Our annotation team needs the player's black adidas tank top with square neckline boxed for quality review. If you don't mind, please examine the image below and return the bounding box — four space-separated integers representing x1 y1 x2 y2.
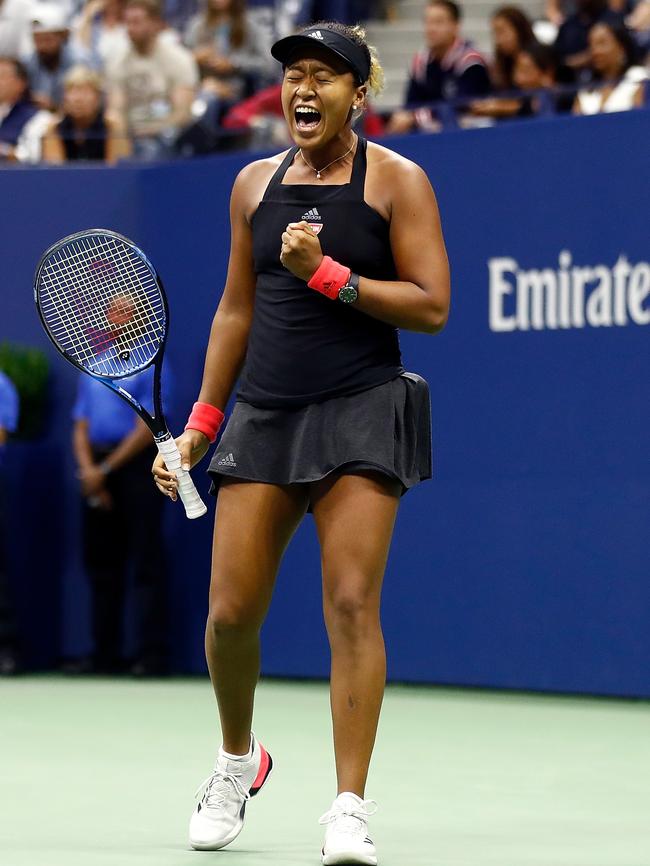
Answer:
237 138 404 408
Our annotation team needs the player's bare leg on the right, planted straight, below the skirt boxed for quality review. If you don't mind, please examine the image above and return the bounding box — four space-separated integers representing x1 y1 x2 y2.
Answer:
312 473 399 797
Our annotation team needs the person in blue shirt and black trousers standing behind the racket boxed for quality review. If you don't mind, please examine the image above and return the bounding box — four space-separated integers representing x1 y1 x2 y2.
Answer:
73 368 167 675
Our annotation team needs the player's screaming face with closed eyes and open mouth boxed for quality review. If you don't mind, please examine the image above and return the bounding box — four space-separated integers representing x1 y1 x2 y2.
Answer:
282 46 365 150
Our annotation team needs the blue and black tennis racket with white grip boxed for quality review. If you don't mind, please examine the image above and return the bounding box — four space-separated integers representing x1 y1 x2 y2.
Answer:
34 229 207 519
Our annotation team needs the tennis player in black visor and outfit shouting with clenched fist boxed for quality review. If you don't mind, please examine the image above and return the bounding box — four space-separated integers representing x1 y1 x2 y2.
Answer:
153 23 449 864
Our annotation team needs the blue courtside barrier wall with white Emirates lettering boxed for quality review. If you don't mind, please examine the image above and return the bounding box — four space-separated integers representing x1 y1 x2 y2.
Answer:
0 112 650 697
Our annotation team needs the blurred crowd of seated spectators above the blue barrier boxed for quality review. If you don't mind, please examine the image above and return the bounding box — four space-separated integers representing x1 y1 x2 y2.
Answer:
0 0 650 163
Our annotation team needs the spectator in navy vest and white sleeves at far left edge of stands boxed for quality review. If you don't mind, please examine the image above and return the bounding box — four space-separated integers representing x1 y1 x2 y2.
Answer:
0 57 52 162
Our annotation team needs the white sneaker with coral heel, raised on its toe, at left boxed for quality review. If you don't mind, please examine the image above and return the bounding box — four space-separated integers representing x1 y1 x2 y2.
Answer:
190 734 273 851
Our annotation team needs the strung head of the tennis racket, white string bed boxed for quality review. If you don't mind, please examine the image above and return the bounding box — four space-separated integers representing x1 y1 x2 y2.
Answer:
38 234 166 377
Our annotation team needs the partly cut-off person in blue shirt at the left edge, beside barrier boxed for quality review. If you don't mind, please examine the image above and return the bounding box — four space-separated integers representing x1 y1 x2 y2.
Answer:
0 370 20 676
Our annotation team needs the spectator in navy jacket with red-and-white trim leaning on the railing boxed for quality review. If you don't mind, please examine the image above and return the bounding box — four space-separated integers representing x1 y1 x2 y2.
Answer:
387 0 490 133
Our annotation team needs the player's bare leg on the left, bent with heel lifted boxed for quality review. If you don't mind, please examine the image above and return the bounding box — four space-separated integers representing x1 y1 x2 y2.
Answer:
205 479 307 755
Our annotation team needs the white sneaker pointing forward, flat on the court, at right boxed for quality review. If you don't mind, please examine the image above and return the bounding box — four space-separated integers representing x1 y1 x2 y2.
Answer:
318 791 377 866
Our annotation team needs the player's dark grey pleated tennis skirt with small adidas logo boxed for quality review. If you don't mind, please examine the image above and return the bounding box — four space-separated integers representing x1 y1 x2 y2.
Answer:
208 373 432 496
